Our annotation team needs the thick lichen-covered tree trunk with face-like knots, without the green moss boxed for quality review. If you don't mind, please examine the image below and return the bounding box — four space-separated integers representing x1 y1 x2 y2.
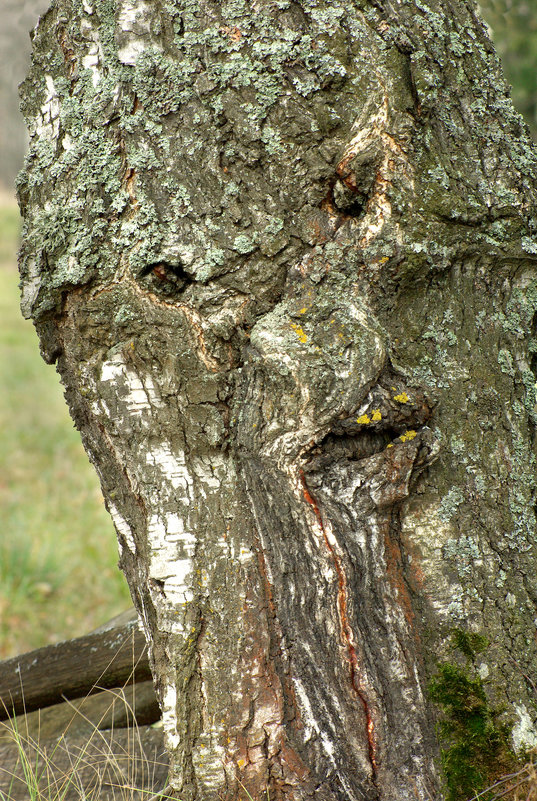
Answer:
19 0 537 801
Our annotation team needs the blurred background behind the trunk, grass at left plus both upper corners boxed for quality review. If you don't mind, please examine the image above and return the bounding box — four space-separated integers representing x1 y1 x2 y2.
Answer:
0 0 537 658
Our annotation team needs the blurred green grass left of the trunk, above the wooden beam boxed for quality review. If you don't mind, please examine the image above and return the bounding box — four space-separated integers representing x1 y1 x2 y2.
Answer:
0 196 130 658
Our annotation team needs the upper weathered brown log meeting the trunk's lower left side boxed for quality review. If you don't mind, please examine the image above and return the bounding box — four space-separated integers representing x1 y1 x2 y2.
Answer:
0 623 151 720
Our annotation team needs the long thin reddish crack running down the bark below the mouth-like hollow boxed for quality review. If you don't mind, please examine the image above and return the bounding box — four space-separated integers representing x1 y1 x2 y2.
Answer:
299 470 377 783
